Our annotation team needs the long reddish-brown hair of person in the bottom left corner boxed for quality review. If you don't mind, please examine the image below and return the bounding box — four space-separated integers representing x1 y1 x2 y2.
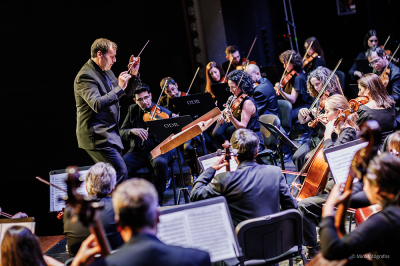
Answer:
1 226 47 266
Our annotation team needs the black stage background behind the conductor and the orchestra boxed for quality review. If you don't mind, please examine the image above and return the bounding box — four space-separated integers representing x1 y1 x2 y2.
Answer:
0 0 400 235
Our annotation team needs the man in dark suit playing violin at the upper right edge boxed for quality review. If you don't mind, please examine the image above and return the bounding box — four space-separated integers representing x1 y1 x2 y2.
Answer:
365 46 400 106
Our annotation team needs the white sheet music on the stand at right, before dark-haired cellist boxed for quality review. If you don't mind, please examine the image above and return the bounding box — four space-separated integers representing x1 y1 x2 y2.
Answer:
326 142 368 184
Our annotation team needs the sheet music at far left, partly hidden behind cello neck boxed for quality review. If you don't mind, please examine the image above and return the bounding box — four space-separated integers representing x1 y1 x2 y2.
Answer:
50 170 88 212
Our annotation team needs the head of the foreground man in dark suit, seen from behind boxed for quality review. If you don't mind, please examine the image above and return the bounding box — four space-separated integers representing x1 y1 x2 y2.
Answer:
113 178 159 232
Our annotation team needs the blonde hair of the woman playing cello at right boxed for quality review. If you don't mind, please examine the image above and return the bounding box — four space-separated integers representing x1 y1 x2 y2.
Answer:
325 94 360 133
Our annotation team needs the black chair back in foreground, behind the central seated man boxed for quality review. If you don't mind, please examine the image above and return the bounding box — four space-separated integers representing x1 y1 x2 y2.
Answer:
236 209 306 266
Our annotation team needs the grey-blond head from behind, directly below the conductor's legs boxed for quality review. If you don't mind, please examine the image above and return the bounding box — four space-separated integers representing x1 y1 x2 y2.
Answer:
86 162 117 198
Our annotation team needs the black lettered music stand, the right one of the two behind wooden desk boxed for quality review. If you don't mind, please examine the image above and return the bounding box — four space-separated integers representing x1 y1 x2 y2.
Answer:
172 93 215 154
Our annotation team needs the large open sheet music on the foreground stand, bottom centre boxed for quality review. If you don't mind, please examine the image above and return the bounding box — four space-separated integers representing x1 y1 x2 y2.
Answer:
157 203 239 262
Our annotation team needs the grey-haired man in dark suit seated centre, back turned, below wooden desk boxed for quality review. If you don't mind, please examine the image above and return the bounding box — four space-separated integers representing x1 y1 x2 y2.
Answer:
190 129 297 226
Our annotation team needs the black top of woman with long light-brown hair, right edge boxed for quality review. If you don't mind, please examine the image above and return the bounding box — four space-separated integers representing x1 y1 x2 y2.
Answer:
357 105 397 145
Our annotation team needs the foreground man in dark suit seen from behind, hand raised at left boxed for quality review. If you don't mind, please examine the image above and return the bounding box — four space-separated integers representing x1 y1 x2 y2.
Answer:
71 178 211 266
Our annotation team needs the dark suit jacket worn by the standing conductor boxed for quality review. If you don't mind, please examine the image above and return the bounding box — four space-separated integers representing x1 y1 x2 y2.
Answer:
74 59 139 150
